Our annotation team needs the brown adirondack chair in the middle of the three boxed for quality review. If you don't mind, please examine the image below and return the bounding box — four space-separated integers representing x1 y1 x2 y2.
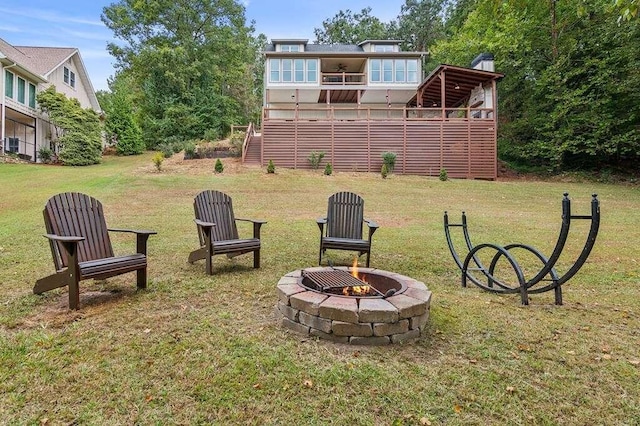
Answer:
189 190 267 275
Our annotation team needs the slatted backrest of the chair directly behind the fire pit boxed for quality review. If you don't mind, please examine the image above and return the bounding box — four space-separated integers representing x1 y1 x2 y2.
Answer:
327 192 364 240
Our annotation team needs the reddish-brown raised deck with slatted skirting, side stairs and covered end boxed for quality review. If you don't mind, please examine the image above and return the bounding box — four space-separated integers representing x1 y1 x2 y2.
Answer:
243 65 502 179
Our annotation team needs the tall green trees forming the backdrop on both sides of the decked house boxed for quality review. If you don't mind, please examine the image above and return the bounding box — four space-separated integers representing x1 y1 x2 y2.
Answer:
100 0 640 173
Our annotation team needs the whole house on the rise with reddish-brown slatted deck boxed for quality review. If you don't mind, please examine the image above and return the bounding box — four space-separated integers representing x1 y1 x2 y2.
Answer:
248 39 502 179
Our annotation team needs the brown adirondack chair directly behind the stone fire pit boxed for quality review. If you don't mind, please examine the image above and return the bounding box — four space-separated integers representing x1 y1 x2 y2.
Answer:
316 192 378 268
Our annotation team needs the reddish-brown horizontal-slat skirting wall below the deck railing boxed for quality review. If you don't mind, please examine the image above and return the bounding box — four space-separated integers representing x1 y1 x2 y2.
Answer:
261 120 497 179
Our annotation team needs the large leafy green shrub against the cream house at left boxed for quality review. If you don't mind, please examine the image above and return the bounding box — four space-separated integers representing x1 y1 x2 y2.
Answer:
37 86 102 166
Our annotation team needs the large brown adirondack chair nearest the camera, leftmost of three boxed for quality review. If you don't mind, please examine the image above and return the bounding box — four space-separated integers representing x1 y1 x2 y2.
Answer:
33 192 156 309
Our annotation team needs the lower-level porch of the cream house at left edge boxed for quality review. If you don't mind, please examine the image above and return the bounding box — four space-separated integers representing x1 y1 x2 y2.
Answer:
0 106 38 162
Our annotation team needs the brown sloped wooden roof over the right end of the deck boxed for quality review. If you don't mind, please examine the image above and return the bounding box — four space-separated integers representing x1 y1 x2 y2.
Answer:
408 64 504 108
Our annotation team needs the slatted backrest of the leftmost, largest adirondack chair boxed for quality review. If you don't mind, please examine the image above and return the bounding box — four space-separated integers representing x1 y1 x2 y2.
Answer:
43 192 113 270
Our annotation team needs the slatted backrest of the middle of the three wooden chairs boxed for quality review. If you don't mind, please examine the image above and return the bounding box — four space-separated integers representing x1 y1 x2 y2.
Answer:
193 190 238 245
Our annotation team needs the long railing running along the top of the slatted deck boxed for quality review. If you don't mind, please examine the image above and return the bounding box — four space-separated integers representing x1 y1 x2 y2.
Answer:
262 106 494 121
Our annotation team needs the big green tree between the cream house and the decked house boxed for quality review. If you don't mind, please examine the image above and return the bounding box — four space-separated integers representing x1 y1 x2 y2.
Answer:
102 0 260 148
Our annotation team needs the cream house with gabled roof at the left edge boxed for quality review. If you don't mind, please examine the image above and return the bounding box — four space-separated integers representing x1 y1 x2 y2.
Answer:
0 39 101 162
